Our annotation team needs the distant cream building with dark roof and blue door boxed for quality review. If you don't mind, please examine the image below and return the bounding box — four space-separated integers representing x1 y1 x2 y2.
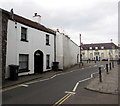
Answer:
81 42 119 60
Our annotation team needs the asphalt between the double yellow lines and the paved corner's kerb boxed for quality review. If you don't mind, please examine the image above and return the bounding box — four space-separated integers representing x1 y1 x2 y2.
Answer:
62 80 118 106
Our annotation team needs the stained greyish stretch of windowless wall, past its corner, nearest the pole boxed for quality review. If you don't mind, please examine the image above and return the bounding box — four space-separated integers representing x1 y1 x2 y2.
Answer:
63 35 80 68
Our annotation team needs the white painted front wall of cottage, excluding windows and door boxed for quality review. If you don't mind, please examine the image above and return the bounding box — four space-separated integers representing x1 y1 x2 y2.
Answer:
6 20 54 78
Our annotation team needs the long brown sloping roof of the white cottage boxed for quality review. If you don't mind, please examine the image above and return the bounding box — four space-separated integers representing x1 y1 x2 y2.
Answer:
2 9 56 35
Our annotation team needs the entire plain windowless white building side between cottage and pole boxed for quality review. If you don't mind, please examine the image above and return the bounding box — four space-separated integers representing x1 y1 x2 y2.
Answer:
56 31 80 70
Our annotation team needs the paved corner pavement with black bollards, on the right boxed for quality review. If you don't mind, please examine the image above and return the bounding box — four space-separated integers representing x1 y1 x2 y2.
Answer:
85 65 120 94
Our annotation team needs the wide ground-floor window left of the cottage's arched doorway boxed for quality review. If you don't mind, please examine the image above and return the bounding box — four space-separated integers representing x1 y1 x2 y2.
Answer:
19 54 29 72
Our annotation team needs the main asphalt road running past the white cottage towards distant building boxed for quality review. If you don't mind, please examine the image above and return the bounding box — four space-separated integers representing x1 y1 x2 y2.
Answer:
2 63 112 104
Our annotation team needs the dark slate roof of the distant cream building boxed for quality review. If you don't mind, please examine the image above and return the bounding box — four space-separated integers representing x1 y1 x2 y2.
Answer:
81 43 119 50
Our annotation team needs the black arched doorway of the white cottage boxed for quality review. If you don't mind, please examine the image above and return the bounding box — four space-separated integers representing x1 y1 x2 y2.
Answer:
34 50 43 73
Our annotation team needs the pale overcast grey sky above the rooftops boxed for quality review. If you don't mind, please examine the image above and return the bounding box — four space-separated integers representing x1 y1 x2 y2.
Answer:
0 0 119 45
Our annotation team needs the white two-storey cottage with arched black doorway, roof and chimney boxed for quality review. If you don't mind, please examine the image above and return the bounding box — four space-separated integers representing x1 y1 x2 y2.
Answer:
4 11 55 78
